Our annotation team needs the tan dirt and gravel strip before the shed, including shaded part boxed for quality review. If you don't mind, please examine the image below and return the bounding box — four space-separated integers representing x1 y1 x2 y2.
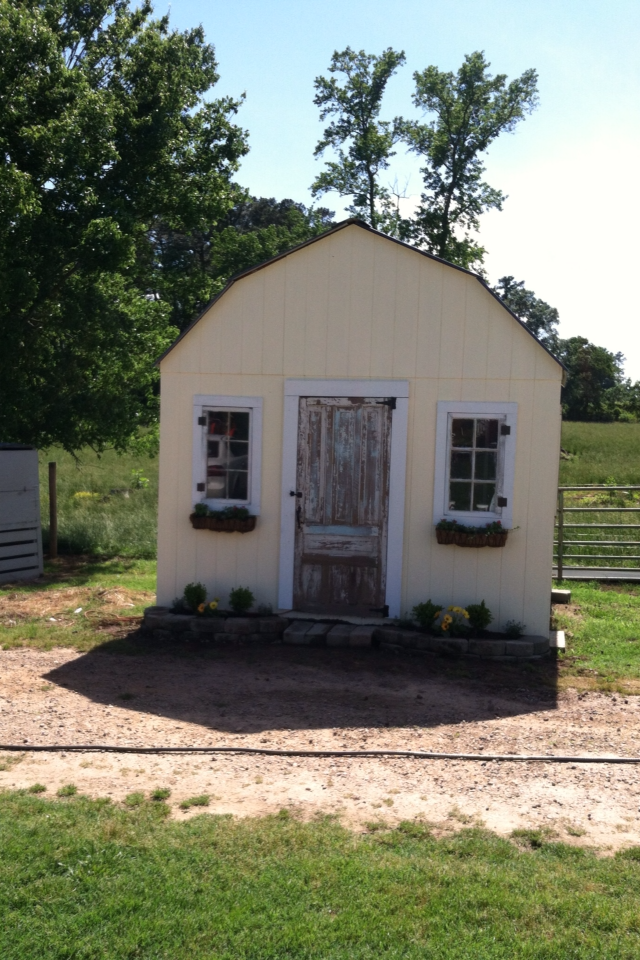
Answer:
0 646 640 850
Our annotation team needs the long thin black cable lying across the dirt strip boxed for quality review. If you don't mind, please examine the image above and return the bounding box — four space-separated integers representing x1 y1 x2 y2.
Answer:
0 743 640 764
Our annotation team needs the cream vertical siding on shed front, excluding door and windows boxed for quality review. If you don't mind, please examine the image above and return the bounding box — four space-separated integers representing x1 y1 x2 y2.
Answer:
158 225 562 634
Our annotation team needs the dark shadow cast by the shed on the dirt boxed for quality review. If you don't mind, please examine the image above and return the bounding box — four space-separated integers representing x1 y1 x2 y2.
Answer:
46 634 557 738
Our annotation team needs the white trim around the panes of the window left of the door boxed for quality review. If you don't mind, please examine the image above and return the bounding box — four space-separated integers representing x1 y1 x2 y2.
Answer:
191 393 262 517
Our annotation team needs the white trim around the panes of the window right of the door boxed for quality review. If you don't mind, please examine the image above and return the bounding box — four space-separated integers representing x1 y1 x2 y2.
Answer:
433 400 518 529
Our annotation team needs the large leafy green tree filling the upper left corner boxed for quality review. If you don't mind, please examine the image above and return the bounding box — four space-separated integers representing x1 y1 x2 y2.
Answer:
0 0 247 450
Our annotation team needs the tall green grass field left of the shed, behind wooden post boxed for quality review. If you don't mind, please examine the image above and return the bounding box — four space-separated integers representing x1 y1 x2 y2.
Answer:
39 449 158 559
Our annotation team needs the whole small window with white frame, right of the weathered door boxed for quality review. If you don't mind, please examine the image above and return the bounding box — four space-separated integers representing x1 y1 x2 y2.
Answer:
434 401 517 525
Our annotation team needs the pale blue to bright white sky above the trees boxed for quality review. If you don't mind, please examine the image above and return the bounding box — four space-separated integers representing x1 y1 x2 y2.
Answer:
166 0 640 380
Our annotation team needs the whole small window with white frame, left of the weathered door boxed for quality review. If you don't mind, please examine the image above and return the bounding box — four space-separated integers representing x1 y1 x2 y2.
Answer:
193 396 262 514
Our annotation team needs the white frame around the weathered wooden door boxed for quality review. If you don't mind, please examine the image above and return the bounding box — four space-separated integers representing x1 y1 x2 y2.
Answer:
278 379 409 617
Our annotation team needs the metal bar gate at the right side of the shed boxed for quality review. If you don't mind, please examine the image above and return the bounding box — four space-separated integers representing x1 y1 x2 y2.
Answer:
553 484 640 580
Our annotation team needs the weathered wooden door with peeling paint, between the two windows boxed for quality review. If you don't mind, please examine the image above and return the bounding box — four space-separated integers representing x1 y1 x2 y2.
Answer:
294 397 393 617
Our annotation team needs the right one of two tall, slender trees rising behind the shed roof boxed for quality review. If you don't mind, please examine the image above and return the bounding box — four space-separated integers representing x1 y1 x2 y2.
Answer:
403 52 538 268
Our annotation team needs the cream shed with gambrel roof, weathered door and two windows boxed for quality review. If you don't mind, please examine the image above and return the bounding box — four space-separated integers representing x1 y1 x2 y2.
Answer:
158 220 563 635
